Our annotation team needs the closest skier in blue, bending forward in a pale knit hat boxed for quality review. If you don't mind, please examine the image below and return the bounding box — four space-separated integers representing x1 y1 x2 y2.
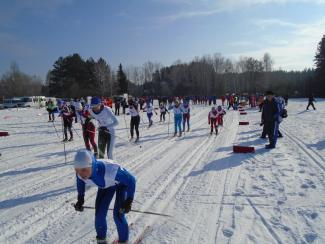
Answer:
74 150 136 243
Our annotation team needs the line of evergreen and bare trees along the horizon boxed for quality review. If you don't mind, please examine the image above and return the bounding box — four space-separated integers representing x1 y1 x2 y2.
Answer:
0 35 325 98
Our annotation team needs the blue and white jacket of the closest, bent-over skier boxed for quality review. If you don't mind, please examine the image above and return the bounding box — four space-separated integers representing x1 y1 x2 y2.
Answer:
76 158 136 199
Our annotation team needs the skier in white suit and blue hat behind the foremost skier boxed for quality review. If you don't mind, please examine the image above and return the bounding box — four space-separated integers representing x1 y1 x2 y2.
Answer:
87 97 118 159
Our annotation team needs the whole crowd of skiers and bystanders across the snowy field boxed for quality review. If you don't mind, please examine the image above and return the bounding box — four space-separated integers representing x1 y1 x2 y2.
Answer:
40 91 315 243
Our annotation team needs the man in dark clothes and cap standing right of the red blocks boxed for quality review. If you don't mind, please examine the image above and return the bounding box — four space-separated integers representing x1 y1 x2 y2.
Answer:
262 91 281 149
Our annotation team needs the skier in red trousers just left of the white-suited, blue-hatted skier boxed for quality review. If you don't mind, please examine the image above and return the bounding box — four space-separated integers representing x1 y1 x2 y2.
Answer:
75 102 98 158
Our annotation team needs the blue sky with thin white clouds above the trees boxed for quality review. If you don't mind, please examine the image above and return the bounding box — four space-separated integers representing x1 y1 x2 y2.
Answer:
0 0 325 78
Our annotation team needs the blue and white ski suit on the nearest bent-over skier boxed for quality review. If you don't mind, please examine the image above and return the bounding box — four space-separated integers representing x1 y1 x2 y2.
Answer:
76 158 136 242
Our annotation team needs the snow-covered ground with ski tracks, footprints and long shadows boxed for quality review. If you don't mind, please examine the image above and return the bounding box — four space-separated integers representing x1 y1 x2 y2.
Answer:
0 100 325 244
